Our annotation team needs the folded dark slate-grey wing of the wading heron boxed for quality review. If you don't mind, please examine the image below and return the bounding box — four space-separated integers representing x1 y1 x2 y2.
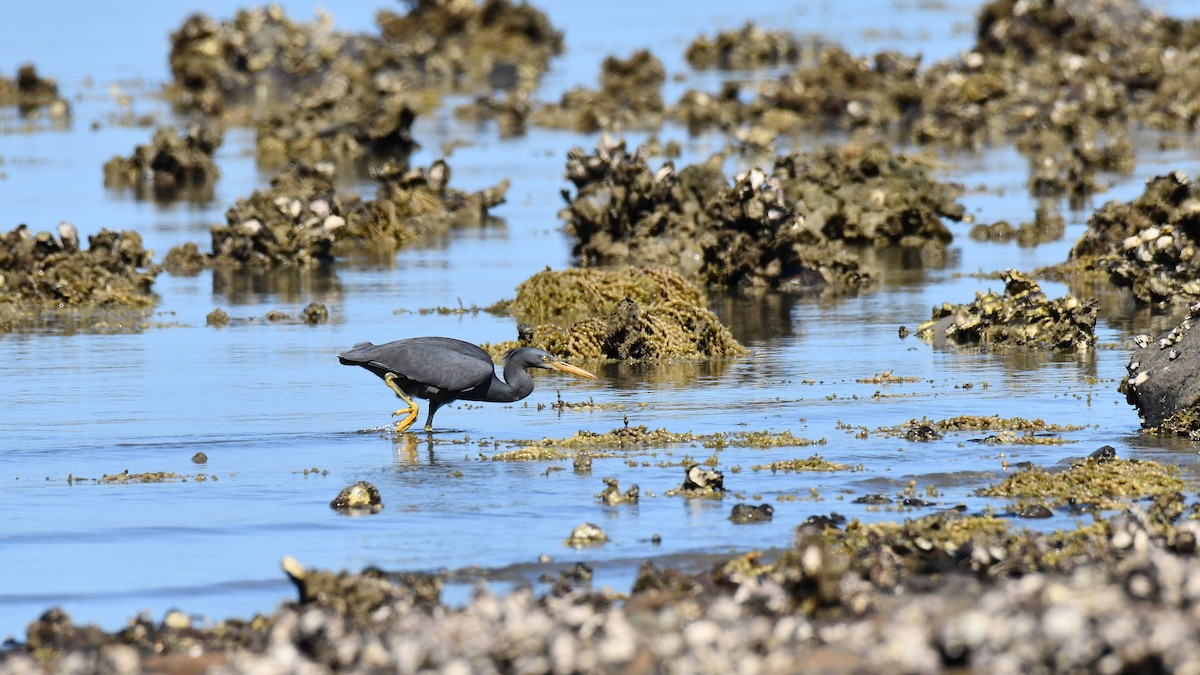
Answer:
347 338 496 392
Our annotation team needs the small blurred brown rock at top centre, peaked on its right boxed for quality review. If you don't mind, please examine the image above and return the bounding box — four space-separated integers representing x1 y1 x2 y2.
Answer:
533 49 666 132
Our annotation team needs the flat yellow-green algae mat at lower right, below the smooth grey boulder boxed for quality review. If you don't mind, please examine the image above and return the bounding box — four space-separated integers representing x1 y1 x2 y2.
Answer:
976 459 1187 508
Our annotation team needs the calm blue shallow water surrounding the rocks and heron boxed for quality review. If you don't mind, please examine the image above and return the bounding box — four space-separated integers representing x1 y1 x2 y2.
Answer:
0 0 1198 638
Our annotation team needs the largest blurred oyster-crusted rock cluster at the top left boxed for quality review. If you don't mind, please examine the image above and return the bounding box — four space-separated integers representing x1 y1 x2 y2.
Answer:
170 0 562 162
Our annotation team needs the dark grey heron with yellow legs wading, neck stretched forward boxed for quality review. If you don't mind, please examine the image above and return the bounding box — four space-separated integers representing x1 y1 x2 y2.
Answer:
337 338 596 432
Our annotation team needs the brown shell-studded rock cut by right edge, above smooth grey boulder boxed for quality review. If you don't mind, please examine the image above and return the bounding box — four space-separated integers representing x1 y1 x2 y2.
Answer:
1062 172 1200 303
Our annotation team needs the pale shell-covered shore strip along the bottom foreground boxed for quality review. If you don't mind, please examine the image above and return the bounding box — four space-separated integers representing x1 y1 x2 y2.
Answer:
16 504 1200 673
